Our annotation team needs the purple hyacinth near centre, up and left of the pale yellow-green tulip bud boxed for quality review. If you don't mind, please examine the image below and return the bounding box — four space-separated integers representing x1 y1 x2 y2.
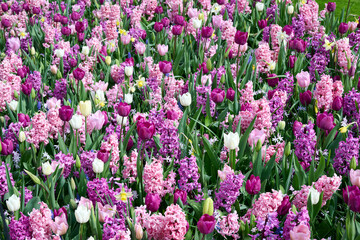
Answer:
178 156 203 201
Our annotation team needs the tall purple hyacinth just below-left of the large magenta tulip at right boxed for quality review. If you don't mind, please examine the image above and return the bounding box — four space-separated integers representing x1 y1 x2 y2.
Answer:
294 122 316 169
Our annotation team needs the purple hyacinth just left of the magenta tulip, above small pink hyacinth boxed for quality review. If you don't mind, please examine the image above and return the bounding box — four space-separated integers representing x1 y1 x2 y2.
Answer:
214 173 245 212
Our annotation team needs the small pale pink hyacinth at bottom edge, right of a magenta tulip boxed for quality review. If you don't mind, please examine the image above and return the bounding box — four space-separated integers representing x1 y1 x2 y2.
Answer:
217 212 240 239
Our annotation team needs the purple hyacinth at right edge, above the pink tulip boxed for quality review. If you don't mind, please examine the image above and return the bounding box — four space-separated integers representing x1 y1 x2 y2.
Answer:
333 134 360 175
